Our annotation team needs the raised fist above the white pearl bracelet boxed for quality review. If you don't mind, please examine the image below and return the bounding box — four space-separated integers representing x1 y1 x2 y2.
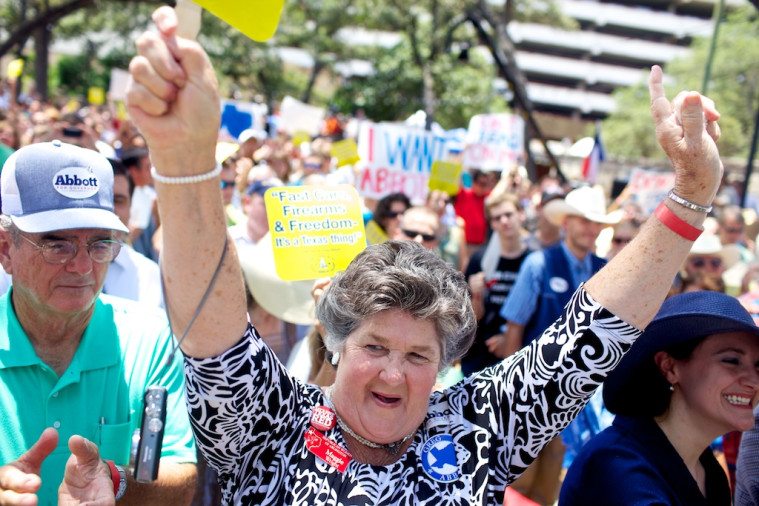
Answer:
127 7 221 171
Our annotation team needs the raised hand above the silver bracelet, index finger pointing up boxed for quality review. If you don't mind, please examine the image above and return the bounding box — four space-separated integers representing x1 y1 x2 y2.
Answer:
648 65 722 205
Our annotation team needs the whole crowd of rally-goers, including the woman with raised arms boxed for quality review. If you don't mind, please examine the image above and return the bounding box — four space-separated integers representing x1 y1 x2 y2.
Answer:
0 4 759 506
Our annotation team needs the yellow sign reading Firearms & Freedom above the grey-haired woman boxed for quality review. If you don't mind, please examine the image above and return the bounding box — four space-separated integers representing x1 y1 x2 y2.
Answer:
264 185 366 281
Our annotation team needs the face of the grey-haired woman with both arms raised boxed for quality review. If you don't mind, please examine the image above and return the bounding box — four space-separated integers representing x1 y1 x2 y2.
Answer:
333 309 441 444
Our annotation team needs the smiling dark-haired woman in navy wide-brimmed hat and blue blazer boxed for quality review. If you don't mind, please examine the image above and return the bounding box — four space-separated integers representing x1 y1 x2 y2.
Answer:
559 291 759 506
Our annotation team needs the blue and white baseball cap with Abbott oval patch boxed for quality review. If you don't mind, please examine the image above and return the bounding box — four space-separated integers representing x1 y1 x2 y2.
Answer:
0 140 128 233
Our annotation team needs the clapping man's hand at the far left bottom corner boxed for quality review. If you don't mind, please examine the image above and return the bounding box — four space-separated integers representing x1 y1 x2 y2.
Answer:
0 428 58 505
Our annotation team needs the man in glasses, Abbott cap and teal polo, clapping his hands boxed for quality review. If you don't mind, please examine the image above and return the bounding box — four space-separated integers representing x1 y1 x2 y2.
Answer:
0 141 196 505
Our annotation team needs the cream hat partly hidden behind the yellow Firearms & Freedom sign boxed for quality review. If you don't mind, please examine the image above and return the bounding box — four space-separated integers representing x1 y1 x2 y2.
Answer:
238 234 315 325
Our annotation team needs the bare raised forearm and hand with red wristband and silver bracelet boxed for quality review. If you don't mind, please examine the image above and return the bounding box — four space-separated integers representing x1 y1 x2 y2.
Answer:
585 66 722 329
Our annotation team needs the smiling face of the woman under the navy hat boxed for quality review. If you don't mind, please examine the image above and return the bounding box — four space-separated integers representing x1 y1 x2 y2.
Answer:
659 332 759 437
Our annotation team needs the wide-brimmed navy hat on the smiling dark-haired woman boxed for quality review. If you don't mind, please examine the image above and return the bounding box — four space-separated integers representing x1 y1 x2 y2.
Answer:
603 291 759 415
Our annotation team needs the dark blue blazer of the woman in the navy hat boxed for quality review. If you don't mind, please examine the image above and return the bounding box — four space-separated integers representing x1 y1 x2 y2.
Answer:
559 415 730 506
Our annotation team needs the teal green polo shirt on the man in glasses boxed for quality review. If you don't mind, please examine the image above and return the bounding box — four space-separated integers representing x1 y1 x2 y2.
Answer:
0 291 195 505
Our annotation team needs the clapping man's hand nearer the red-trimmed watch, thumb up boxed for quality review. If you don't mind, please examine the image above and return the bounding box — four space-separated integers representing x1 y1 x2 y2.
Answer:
58 436 116 506
